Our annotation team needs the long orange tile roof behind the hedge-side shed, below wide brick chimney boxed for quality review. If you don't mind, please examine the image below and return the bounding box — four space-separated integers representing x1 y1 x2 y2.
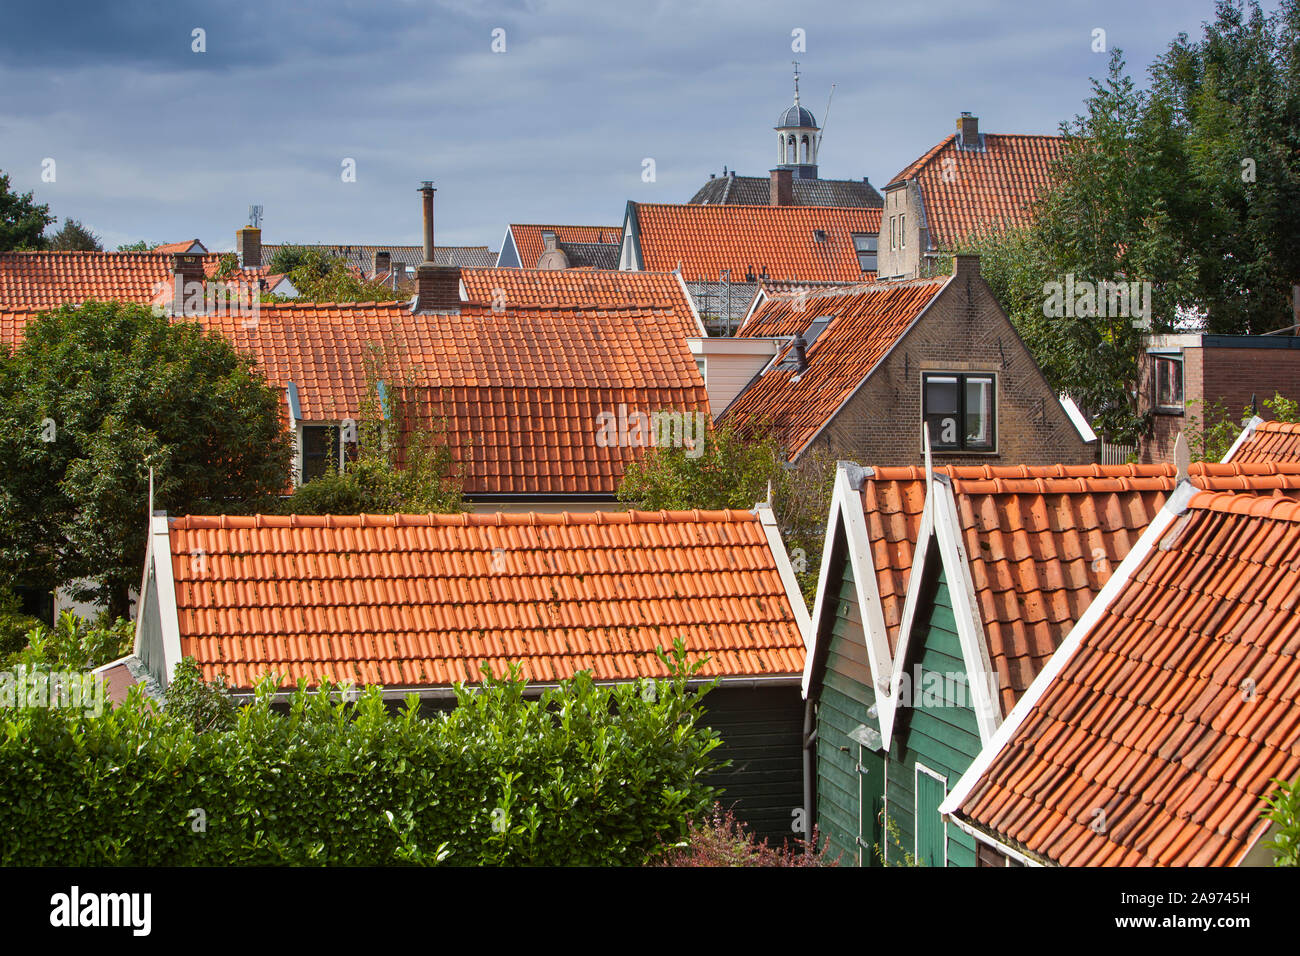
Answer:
189 302 709 496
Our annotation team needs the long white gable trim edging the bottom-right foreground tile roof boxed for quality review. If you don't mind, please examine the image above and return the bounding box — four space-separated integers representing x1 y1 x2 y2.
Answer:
939 481 1197 813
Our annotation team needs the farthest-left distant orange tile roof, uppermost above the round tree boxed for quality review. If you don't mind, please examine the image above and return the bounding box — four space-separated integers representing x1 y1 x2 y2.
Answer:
0 252 221 310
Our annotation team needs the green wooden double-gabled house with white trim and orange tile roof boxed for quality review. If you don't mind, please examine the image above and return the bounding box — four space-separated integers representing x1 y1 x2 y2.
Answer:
803 463 1174 866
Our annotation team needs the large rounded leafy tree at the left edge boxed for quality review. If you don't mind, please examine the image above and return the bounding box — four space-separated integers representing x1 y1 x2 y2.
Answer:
0 302 291 617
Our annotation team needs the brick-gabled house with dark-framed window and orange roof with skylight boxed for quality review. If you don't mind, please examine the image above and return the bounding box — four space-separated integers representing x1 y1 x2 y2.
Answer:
722 256 1096 464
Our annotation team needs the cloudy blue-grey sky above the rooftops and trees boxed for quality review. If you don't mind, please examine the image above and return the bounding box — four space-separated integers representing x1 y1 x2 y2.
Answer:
0 0 1271 251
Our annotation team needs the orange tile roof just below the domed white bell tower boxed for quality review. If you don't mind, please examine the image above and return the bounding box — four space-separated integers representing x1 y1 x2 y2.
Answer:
631 203 880 282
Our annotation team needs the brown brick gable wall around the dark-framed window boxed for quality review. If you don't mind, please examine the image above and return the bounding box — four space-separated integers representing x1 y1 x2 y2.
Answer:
811 265 1097 466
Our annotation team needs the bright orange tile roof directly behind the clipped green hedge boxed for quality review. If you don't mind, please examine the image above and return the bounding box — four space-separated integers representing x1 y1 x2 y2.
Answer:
169 511 803 688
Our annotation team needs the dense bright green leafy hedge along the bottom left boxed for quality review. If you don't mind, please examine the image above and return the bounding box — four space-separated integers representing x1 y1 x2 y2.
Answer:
0 653 719 866
